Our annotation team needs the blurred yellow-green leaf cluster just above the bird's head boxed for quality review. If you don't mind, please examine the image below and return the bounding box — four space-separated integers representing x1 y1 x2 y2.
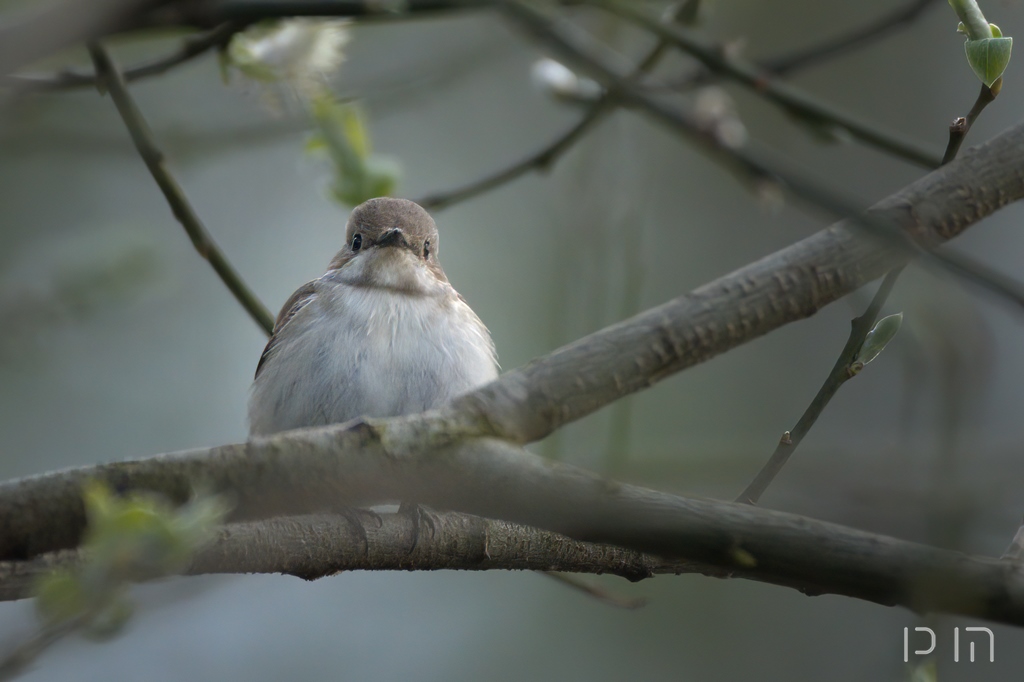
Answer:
306 94 399 206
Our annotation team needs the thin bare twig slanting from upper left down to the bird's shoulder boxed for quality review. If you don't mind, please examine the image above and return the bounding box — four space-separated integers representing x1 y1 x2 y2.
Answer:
89 43 273 335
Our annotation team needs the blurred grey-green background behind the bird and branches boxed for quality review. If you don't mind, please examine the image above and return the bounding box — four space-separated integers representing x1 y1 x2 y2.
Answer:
0 0 1024 682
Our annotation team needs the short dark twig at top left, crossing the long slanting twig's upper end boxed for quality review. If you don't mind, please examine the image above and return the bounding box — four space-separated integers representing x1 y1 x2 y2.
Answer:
4 23 240 91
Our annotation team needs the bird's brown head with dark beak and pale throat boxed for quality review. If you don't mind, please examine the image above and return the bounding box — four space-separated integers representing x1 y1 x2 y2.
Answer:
331 197 447 289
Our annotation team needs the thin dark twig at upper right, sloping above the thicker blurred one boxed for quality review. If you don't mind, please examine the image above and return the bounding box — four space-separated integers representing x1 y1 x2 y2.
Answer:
587 0 941 168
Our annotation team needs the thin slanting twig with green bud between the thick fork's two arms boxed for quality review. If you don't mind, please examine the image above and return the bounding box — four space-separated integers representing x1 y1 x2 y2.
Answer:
736 267 903 505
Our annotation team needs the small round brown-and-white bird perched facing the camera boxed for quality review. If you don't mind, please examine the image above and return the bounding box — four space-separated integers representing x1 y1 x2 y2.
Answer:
249 198 498 436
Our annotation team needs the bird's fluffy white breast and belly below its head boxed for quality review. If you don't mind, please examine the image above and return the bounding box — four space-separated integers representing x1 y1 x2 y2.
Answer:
249 278 498 435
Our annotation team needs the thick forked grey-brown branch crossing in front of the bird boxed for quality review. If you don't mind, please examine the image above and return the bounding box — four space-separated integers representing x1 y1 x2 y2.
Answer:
6 119 1024 623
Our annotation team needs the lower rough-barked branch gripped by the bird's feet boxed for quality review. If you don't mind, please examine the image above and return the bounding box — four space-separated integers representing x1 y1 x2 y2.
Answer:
0 509 715 601
